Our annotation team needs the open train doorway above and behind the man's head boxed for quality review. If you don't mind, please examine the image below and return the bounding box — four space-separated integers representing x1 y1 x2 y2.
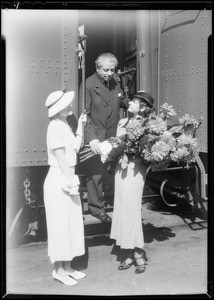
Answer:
79 10 137 97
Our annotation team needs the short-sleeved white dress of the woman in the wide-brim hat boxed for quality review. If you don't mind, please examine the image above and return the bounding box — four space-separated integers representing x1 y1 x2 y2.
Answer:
44 120 85 263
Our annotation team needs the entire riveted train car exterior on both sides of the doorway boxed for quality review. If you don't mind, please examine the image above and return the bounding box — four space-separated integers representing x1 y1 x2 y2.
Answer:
2 9 212 246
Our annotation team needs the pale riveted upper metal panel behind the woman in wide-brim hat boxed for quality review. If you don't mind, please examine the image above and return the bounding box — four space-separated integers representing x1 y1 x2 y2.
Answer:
2 10 78 167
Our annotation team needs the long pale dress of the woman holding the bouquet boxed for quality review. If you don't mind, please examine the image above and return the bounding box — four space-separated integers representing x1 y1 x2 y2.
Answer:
110 119 146 249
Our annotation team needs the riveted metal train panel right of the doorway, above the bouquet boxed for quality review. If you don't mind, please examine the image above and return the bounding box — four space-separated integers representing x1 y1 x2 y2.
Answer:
159 10 212 152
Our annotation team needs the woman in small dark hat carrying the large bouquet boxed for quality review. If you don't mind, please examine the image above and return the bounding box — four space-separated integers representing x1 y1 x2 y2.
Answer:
110 91 154 274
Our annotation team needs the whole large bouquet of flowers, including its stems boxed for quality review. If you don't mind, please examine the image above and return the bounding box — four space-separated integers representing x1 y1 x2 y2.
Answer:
80 103 202 170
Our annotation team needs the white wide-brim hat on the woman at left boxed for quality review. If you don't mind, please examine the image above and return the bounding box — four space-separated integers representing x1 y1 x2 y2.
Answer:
45 91 74 118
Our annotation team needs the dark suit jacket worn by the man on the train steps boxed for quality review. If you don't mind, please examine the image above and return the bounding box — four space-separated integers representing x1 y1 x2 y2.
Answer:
81 73 123 144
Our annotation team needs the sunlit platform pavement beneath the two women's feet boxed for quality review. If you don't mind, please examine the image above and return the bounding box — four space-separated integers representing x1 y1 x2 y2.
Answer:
6 198 208 299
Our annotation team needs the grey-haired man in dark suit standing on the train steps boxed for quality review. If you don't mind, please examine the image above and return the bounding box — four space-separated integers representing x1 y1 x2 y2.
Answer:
80 53 127 222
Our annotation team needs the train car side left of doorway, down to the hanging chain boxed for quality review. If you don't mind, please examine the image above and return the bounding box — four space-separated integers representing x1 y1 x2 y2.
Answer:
2 9 78 247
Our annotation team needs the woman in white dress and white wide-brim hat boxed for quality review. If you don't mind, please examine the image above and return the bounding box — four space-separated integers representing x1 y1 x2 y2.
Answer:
44 91 86 285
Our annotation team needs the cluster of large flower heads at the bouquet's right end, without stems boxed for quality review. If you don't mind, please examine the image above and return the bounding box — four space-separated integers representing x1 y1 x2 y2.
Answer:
141 103 202 170
